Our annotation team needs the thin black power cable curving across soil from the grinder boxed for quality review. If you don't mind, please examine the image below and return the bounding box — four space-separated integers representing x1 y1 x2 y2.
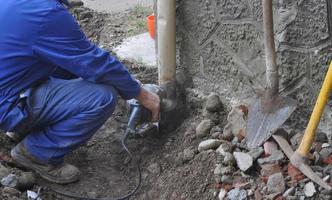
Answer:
48 129 142 200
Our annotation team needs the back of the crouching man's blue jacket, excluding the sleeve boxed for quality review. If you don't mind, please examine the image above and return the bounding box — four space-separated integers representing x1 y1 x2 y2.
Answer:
0 0 57 98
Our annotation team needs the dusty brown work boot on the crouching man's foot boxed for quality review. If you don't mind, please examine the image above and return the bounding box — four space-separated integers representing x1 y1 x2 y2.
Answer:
10 143 80 184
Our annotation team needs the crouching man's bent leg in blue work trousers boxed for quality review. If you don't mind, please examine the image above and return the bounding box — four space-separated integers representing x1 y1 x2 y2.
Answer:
23 79 117 164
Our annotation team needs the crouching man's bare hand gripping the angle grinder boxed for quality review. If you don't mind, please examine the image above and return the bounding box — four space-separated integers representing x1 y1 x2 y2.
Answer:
136 87 160 122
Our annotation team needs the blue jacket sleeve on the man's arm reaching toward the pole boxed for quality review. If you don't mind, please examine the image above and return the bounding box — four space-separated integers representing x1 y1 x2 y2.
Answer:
33 3 141 99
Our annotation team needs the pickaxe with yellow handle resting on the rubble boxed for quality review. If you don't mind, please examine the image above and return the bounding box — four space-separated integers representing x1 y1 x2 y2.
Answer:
273 62 332 190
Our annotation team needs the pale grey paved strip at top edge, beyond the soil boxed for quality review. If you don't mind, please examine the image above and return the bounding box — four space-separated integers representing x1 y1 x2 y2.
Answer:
83 0 153 13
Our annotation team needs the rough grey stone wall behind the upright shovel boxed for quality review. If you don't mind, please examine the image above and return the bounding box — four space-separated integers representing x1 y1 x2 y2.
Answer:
177 0 332 128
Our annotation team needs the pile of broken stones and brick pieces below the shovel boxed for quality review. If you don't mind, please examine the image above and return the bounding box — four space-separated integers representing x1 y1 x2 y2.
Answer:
192 93 332 200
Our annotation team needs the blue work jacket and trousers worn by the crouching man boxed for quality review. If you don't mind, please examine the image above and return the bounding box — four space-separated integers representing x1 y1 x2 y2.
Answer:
0 0 140 164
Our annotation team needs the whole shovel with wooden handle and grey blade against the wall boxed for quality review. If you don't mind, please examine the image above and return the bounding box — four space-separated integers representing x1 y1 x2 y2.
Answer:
246 0 296 149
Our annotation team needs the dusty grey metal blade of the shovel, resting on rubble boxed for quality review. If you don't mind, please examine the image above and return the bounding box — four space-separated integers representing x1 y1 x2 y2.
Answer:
246 94 296 149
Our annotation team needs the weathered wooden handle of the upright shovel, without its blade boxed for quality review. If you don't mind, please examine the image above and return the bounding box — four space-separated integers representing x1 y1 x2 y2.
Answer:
262 0 279 97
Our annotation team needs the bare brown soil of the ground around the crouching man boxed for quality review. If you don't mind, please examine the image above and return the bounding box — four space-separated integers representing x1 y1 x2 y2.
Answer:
0 2 215 200
